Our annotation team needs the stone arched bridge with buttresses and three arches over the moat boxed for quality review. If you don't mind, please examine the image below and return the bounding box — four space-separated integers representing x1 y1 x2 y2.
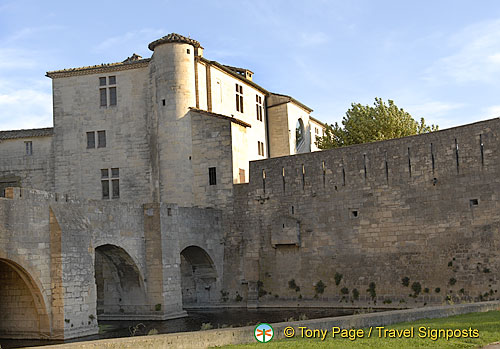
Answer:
0 188 224 339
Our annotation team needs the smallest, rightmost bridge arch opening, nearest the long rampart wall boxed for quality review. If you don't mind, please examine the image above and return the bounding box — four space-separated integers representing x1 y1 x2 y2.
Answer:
181 246 218 305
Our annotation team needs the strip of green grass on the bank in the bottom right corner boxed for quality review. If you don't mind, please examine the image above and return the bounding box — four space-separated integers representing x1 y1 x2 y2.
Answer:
224 311 500 349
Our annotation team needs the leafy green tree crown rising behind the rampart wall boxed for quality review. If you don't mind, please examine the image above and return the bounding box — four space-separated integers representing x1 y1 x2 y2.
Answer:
316 98 438 149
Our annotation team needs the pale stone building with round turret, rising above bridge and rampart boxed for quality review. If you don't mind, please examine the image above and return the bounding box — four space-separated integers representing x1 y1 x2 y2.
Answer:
0 34 324 207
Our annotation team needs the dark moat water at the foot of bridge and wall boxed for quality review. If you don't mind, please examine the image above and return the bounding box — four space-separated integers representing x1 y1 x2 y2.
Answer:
0 308 360 349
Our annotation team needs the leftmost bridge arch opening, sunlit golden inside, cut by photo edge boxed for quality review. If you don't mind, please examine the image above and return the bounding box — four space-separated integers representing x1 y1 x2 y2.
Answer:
0 258 51 339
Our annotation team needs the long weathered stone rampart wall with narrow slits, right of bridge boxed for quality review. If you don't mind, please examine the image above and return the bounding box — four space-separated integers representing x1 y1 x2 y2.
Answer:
228 119 500 304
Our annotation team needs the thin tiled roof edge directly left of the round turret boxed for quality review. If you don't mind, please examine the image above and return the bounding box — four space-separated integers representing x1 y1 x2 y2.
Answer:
45 57 151 79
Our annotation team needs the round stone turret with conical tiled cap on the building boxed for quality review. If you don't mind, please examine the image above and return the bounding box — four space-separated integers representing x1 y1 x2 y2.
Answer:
148 33 202 206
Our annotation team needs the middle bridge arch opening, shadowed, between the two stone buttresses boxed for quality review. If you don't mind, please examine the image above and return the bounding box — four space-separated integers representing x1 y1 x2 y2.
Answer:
94 245 149 320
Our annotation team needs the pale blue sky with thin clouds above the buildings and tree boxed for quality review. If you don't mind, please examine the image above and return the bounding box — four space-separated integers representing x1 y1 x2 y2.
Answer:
0 0 500 130
